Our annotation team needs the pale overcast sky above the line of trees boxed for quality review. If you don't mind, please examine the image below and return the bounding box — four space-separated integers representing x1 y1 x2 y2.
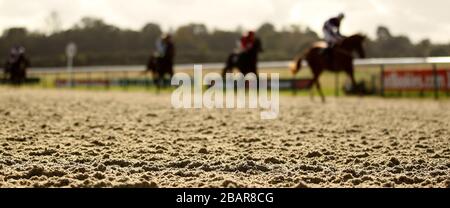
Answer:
0 0 450 42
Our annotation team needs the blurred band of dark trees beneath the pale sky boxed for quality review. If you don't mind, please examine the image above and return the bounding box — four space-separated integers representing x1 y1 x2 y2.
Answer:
0 18 450 67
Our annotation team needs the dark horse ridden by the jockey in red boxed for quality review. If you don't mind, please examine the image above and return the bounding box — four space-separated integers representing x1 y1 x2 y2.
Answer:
222 38 263 77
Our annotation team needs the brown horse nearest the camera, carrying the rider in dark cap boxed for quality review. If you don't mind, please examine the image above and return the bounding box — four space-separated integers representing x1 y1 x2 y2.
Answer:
292 34 366 102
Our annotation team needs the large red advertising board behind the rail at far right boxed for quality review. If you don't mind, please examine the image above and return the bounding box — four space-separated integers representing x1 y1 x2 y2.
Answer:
383 69 450 91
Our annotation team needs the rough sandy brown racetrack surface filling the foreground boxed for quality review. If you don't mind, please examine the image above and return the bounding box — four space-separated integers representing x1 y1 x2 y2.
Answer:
0 88 450 187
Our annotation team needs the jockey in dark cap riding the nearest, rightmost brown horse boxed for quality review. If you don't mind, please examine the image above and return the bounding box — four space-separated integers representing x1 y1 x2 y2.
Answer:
323 13 345 48
